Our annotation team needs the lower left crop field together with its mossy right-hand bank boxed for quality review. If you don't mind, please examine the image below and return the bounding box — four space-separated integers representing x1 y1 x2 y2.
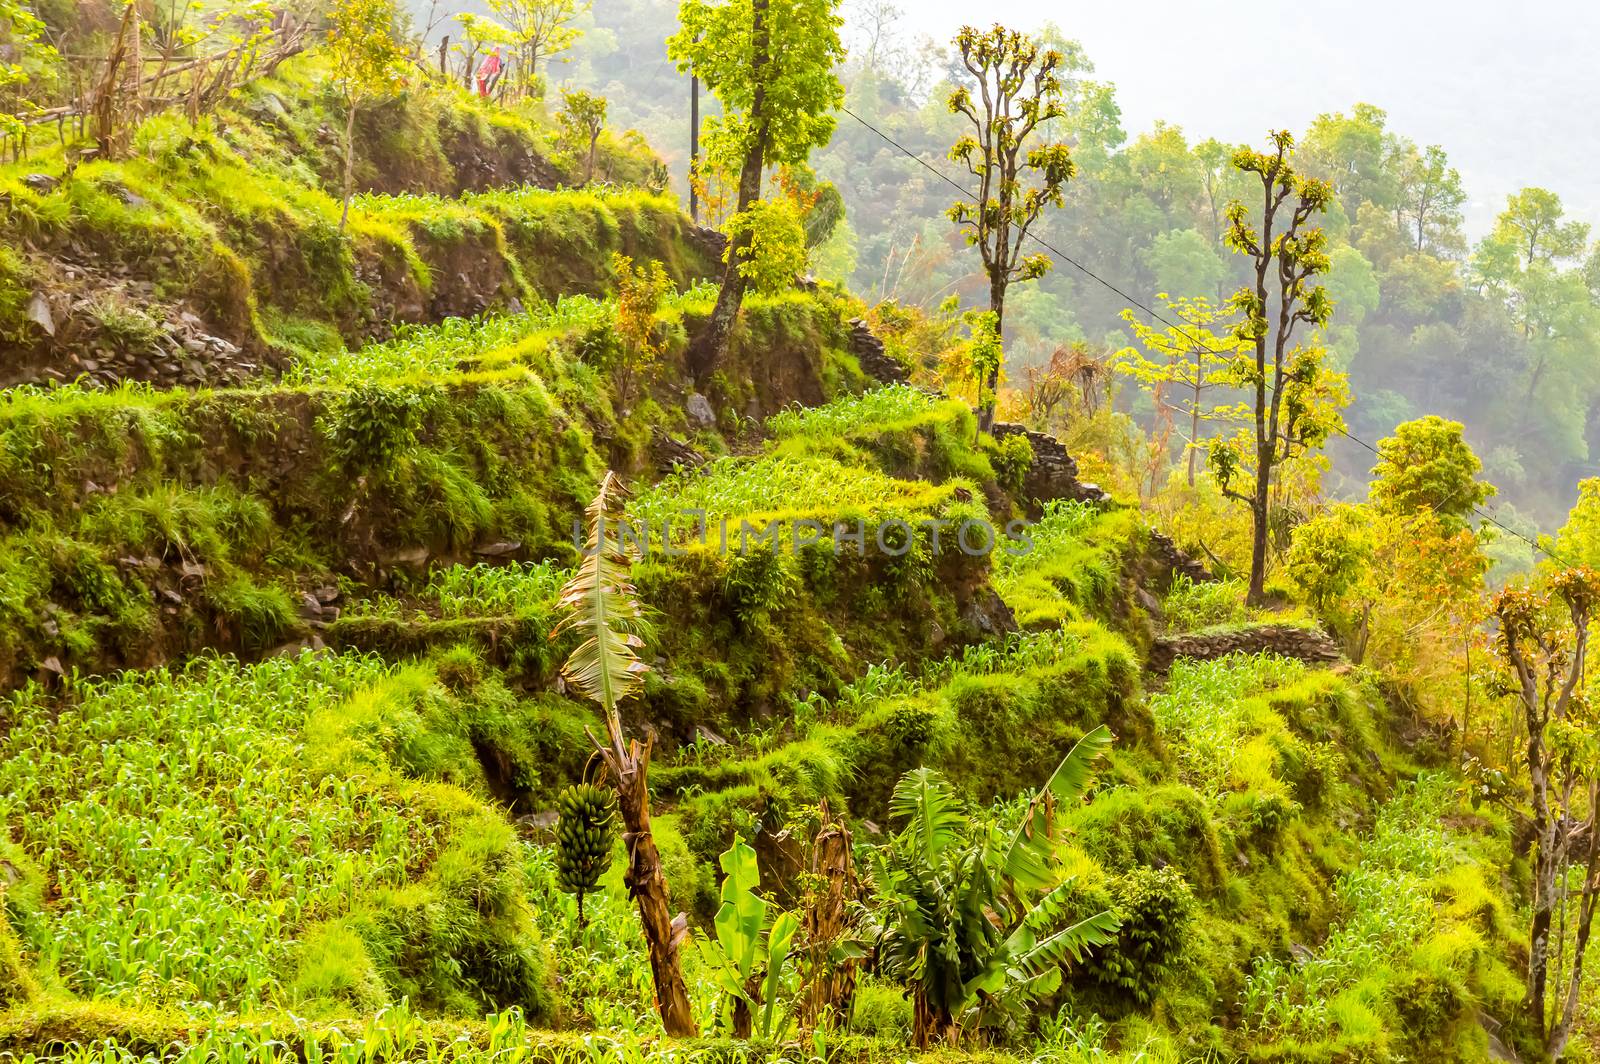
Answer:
0 656 549 1014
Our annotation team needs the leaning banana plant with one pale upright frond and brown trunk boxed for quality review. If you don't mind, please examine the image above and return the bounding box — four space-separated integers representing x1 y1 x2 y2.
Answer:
550 472 698 1038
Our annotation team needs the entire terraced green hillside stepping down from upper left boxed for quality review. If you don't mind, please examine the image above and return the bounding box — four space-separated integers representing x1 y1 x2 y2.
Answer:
0 16 1580 1064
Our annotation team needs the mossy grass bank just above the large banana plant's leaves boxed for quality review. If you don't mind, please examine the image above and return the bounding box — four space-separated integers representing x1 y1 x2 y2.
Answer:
656 626 1149 858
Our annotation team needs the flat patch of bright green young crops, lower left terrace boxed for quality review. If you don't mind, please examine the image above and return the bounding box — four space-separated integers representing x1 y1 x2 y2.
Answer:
0 646 406 1005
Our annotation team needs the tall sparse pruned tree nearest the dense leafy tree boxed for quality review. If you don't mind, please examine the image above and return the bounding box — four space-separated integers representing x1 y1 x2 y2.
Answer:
949 26 1077 432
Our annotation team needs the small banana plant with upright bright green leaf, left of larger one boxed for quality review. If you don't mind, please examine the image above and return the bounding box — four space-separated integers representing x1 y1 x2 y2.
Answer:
694 835 800 1042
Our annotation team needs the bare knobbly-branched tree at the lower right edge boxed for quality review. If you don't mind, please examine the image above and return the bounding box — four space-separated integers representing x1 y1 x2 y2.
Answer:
1494 566 1600 1061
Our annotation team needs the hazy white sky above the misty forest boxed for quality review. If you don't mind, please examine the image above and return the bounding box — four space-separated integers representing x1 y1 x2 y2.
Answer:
901 0 1600 234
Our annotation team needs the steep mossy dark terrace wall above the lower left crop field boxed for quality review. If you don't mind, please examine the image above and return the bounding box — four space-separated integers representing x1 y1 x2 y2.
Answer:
0 355 605 672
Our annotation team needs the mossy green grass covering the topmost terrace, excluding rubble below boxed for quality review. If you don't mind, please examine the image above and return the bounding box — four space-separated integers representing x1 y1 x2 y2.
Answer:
0 56 715 362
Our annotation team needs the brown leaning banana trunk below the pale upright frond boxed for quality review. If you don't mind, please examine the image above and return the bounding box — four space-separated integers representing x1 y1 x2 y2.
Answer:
604 742 699 1038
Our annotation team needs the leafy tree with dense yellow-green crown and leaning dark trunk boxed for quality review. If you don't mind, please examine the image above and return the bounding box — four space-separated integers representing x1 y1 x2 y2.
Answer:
667 0 845 376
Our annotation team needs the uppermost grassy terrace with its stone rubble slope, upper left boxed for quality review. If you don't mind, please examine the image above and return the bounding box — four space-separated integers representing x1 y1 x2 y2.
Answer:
0 58 720 386
